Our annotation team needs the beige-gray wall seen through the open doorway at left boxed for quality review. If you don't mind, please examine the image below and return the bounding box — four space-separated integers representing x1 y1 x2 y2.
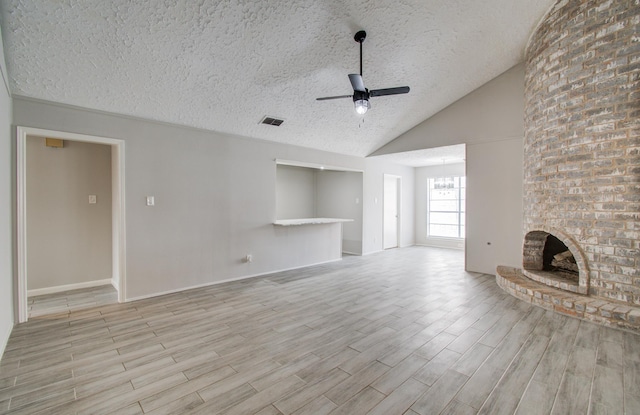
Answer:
26 137 112 290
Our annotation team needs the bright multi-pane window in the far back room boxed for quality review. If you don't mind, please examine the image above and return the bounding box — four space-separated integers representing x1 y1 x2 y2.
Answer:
427 177 466 238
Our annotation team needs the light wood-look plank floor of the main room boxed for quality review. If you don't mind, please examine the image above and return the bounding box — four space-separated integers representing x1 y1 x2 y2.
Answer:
0 247 640 415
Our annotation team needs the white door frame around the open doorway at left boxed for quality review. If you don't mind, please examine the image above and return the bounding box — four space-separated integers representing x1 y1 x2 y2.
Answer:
16 126 127 323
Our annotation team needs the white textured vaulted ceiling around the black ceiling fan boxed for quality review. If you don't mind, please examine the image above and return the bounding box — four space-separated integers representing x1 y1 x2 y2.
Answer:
0 0 554 156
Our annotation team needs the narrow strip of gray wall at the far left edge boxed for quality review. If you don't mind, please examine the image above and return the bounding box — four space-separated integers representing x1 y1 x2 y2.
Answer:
0 26 15 356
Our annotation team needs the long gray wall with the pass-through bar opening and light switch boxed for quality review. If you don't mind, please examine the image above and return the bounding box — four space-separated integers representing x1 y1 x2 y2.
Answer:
13 97 414 299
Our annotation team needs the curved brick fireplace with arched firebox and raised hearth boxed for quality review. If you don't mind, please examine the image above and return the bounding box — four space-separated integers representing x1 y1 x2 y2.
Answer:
496 0 640 331
